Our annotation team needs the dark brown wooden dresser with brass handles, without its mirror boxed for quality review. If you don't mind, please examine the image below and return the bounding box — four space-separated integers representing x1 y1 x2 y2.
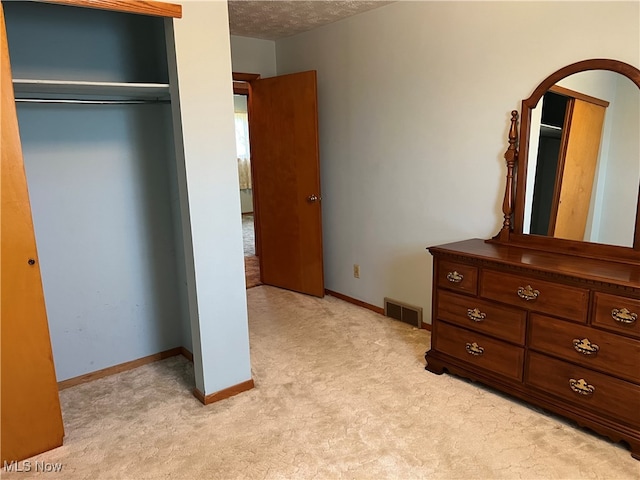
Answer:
426 239 640 458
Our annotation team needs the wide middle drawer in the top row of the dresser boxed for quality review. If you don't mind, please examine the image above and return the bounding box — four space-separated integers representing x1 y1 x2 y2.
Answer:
480 270 589 323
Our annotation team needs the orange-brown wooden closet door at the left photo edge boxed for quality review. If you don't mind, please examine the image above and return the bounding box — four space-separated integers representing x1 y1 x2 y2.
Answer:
0 3 64 465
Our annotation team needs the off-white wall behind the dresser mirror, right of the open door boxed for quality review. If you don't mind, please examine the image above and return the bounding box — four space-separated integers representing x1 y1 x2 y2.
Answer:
276 2 640 319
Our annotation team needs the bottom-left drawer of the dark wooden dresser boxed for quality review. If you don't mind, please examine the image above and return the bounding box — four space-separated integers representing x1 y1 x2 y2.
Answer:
434 321 524 381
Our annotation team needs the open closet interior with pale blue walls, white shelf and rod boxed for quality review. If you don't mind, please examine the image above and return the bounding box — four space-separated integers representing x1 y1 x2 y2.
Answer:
3 2 192 388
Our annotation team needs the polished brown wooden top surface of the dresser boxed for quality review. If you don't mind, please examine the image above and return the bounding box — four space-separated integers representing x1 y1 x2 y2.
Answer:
428 238 640 292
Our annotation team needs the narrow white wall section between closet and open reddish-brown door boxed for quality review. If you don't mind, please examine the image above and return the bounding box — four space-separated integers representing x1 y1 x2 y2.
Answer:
169 0 251 395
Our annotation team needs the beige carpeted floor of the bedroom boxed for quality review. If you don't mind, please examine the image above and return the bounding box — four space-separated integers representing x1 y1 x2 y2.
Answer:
2 286 640 480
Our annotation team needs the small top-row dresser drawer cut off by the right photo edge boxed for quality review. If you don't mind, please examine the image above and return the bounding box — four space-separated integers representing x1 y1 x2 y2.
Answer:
593 292 640 338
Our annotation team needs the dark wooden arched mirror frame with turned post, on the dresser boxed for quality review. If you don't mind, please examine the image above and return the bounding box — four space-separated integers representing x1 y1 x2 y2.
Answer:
493 59 640 263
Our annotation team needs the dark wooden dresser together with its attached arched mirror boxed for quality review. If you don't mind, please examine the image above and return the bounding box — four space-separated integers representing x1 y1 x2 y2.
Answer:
425 59 640 460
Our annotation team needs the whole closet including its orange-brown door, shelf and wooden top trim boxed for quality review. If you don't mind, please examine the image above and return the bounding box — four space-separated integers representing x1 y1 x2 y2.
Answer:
1 1 185 461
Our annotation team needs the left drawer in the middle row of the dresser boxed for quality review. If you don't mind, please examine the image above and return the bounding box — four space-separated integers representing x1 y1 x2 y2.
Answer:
436 290 527 345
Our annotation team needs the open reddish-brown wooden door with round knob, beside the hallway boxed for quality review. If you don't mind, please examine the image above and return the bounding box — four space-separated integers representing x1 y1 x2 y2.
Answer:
249 71 324 297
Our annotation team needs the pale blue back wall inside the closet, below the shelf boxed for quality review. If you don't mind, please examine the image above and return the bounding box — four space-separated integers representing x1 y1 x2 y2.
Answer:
18 105 181 381
